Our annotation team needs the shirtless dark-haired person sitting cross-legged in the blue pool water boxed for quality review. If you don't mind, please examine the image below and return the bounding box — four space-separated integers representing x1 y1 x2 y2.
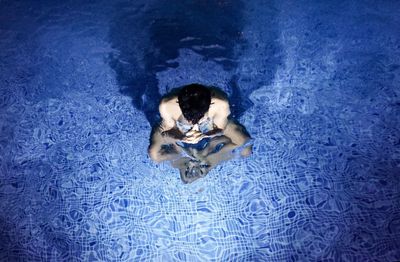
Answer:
149 84 251 183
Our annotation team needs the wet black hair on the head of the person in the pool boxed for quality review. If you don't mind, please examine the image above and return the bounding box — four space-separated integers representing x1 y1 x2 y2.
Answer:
178 84 211 124
